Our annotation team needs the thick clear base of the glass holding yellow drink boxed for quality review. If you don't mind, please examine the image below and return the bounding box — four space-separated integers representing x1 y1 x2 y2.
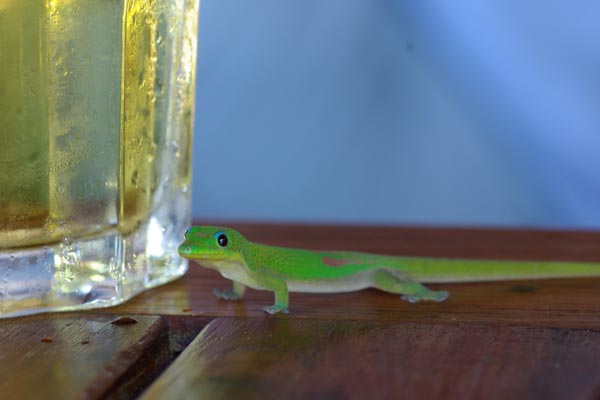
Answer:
0 218 187 318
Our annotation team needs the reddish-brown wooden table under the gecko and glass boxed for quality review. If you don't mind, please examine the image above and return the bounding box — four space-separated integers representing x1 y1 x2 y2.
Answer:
0 224 600 399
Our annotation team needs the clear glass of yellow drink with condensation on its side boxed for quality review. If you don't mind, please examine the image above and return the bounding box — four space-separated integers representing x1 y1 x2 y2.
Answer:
0 0 198 317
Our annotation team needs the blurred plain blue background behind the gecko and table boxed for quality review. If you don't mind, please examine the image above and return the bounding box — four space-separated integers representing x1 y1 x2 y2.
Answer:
193 0 600 228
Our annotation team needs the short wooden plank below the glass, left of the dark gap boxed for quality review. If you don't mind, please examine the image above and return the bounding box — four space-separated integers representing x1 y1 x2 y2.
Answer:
0 313 169 399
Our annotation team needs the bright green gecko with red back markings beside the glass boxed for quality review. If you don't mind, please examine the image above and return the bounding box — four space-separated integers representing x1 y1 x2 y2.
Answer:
179 226 600 314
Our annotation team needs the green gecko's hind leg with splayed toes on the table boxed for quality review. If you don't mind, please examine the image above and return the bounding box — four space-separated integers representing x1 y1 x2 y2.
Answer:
373 270 448 303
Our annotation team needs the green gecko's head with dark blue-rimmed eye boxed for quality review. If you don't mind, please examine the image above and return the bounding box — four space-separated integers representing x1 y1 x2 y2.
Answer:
179 226 247 261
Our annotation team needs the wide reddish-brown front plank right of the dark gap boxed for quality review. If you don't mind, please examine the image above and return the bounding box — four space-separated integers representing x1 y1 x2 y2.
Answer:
143 318 600 399
